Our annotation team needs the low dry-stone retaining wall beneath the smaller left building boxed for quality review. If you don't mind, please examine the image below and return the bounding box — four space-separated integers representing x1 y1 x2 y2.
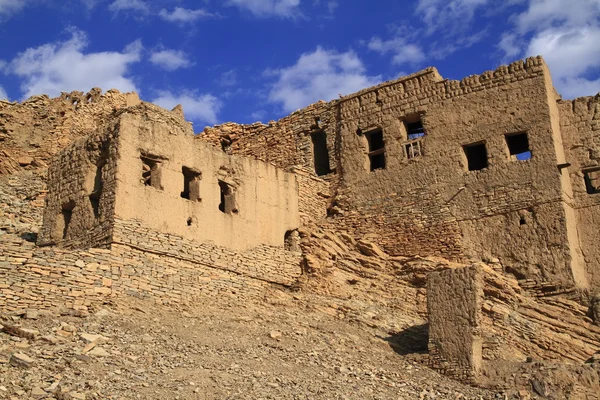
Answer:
0 222 302 312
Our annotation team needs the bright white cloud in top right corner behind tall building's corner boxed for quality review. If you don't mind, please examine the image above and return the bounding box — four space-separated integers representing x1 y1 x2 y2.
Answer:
498 0 600 98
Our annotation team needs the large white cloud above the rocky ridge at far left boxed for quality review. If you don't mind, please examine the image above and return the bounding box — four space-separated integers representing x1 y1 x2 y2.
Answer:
5 31 142 98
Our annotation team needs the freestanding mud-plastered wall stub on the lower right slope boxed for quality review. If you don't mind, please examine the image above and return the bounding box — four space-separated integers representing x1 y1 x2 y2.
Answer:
427 266 483 381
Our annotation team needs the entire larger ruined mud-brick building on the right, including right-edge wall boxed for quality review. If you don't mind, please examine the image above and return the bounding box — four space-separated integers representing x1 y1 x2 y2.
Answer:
200 57 600 288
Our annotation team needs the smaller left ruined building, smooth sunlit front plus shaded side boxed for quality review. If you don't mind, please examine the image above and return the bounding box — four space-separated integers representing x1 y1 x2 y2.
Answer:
38 104 300 250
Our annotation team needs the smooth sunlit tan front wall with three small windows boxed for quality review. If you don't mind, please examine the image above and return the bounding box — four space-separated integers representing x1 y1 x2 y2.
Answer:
115 105 300 250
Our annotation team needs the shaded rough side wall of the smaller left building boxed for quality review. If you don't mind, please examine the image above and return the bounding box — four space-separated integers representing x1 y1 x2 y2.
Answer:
38 125 118 248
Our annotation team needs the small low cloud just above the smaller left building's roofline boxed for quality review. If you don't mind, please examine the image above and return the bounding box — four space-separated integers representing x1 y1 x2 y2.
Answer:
152 91 222 125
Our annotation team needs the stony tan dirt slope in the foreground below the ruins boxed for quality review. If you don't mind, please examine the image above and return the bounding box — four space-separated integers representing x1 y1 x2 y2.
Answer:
0 293 504 399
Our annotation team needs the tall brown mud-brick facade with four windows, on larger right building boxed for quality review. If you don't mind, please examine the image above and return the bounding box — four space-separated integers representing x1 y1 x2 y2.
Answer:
339 58 581 282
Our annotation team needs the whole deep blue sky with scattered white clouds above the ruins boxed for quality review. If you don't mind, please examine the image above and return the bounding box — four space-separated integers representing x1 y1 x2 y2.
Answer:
0 0 600 131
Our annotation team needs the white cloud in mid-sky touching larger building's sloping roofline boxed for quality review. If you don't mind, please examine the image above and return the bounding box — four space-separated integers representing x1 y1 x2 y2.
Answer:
268 47 381 111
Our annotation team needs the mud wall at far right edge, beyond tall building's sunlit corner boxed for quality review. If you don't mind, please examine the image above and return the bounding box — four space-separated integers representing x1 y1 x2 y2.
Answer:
558 96 600 287
